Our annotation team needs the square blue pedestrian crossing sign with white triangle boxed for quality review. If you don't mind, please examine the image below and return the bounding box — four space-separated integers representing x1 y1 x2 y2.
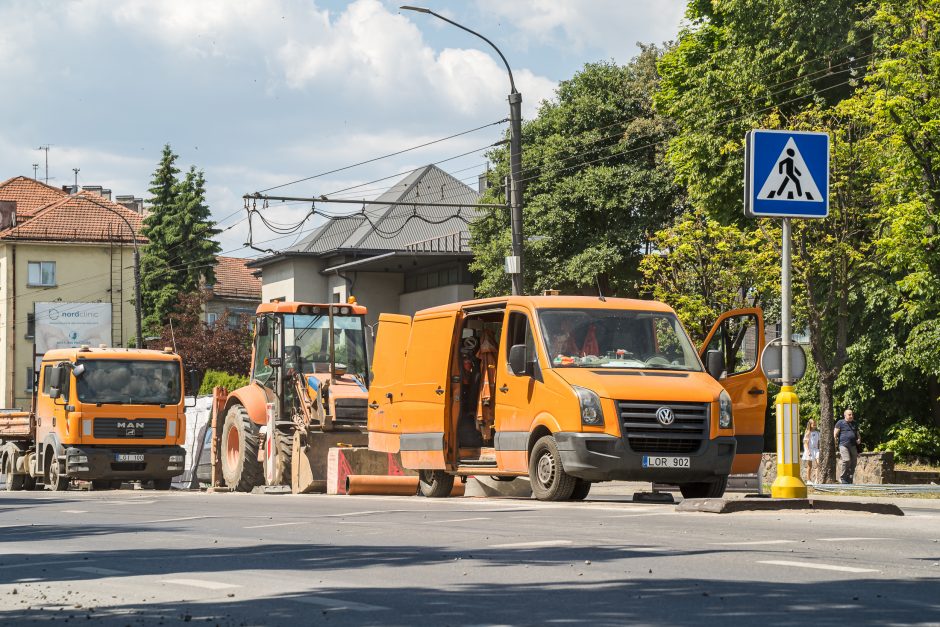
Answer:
744 130 829 218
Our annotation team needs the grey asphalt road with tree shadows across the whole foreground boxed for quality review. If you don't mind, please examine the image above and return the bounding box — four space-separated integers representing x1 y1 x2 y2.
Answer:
0 489 940 626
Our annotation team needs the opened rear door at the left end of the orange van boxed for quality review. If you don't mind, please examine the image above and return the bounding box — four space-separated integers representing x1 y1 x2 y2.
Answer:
368 314 411 453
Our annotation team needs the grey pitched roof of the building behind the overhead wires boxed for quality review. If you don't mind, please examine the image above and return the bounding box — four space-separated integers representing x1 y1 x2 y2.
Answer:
286 165 480 254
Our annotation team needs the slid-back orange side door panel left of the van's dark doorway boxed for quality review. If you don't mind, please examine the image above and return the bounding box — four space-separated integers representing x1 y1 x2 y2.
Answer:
396 310 460 470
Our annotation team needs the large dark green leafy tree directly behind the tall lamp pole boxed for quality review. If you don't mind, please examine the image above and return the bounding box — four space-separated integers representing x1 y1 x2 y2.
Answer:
471 46 682 295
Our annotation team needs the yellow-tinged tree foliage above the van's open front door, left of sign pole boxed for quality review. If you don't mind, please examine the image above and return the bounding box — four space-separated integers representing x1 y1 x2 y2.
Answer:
640 209 780 343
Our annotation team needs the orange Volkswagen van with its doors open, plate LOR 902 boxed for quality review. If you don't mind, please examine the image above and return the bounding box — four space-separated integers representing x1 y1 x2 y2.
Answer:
368 296 767 500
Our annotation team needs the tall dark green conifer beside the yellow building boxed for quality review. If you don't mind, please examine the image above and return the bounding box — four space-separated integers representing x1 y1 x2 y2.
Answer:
140 144 221 333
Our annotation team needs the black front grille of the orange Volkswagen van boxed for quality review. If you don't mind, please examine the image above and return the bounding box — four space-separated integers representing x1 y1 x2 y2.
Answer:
617 401 711 454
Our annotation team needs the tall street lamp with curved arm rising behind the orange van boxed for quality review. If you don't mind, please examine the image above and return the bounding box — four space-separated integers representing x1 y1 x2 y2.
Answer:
399 6 523 294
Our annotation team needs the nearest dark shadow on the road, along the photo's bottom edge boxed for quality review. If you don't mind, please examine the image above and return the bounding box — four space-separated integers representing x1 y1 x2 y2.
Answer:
0 571 940 627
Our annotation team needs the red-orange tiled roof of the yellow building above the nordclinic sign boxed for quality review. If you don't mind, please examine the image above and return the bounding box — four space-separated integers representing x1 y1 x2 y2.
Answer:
0 192 147 243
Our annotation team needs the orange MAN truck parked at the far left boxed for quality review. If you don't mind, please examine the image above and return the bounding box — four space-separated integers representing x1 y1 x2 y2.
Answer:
0 346 196 490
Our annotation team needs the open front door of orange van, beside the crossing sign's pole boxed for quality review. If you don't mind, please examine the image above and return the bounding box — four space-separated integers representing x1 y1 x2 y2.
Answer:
700 307 767 474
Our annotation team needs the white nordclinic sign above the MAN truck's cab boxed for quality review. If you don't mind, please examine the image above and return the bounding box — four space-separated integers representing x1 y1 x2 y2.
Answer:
36 303 111 355
